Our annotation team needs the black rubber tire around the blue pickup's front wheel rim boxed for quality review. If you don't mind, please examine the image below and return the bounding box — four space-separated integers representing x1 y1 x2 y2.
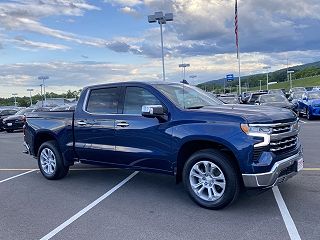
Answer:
182 149 241 210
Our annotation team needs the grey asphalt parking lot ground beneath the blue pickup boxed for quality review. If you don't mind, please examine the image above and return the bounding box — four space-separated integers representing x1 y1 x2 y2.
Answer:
0 119 320 240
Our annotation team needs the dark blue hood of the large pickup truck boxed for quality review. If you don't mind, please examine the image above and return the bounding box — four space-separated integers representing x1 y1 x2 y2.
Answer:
191 104 297 123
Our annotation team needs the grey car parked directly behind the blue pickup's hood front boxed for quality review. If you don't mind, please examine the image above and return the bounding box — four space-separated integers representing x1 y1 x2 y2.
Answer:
255 94 294 110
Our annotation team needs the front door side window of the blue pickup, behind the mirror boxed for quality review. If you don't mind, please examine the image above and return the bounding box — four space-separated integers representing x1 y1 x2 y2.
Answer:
123 87 162 114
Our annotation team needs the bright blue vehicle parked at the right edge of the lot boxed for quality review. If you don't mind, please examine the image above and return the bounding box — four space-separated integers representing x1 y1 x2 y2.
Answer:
298 91 320 120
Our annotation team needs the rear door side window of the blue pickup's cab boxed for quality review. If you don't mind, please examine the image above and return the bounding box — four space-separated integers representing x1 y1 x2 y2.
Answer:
86 87 118 114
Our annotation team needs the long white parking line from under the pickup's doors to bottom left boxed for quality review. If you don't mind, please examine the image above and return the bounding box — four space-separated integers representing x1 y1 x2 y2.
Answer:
40 171 139 240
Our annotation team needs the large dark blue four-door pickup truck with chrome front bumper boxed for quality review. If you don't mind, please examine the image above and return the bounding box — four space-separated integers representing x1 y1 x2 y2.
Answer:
24 82 303 209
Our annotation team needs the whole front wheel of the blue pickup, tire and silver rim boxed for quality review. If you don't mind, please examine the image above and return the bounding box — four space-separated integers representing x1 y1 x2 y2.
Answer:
183 149 240 210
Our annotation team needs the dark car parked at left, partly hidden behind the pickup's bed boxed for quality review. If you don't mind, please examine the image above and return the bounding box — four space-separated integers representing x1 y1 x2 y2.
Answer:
2 107 50 133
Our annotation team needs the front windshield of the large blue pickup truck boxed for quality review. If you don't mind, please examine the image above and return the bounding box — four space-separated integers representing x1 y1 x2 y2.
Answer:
153 84 223 109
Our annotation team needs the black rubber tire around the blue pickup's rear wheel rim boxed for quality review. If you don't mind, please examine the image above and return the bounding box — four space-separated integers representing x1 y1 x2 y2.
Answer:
38 141 69 180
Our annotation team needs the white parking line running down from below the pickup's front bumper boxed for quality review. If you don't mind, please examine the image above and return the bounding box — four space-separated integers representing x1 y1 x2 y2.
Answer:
272 186 301 240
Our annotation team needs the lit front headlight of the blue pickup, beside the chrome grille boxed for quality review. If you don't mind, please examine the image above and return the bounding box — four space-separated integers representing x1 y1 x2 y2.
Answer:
240 124 272 147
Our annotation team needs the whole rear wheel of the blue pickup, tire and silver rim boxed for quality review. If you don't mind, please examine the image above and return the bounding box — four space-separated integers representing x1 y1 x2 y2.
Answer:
38 141 69 180
